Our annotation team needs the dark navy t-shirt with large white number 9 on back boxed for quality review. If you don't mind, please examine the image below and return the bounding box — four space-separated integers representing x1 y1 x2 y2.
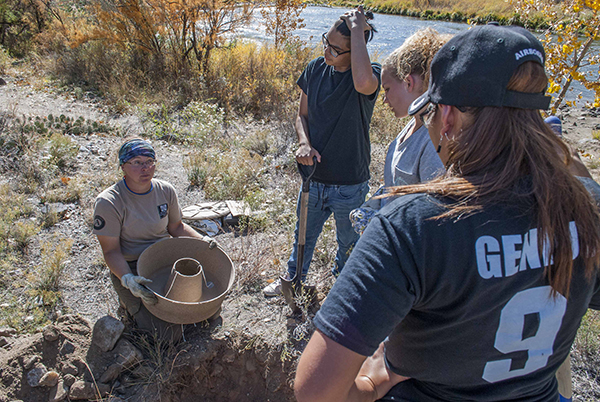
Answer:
314 180 600 401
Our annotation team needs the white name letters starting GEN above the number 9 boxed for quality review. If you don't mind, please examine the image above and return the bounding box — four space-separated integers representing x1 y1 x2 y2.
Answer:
475 222 579 279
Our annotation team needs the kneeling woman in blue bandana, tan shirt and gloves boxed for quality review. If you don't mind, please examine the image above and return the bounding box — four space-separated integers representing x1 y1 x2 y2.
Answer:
93 139 217 341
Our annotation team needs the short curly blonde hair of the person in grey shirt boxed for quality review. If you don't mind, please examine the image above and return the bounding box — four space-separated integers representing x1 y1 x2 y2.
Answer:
382 28 452 89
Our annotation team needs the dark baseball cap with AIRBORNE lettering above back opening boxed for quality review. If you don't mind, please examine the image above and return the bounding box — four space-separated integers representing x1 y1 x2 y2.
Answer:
408 23 551 116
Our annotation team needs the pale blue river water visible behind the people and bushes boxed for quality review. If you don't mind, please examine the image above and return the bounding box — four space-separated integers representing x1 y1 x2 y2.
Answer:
237 6 600 105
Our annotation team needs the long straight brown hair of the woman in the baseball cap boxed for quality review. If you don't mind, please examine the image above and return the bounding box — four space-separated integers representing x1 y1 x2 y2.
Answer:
392 62 600 297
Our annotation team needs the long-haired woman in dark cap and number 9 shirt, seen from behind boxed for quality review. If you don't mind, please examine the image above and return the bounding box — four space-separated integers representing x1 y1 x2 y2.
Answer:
295 25 600 401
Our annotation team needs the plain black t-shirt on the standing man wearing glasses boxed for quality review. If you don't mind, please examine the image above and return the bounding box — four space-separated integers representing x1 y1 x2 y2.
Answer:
298 57 381 185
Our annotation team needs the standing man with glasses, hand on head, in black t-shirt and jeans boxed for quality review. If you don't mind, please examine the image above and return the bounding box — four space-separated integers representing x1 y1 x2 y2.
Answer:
263 6 381 302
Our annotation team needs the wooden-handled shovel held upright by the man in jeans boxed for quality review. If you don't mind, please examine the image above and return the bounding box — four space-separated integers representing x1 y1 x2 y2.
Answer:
279 156 317 313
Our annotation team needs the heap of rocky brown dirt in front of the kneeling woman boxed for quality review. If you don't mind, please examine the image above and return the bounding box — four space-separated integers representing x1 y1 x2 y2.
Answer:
0 315 294 402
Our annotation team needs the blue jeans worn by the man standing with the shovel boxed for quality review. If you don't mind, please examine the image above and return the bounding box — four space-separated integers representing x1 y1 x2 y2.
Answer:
288 182 369 279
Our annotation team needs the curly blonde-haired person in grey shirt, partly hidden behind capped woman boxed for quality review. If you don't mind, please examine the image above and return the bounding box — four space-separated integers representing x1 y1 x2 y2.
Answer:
350 28 451 234
